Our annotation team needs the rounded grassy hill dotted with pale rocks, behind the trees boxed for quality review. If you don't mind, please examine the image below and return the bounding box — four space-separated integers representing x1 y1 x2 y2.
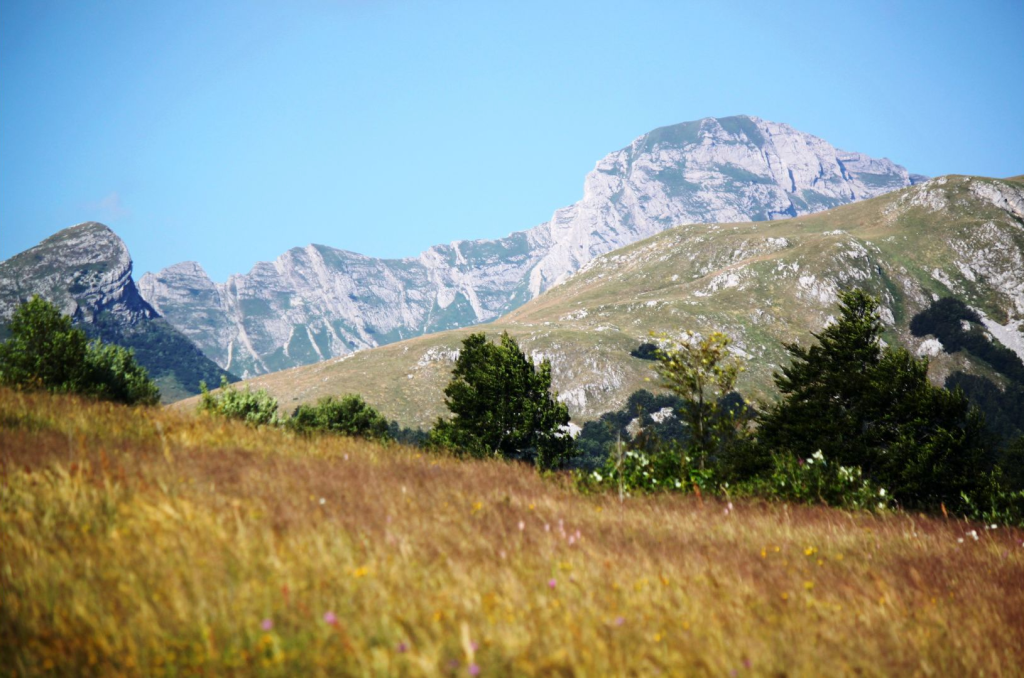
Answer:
180 176 1024 427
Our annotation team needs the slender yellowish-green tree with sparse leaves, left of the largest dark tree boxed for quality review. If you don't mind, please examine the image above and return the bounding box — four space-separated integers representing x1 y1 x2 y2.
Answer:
656 332 743 469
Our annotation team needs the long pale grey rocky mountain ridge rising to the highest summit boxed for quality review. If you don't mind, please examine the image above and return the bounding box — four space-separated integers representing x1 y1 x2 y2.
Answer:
139 116 920 376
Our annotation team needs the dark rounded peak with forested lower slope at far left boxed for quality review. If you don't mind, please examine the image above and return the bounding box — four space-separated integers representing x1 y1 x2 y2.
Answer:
0 221 237 401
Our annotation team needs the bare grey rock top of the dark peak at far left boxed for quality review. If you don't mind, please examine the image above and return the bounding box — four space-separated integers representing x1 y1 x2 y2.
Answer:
0 221 157 325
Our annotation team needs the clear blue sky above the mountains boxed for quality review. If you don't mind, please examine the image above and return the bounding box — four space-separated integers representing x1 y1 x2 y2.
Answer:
0 0 1024 281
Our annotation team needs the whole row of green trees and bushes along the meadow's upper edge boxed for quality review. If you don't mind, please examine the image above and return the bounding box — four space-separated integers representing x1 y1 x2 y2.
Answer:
0 290 1024 525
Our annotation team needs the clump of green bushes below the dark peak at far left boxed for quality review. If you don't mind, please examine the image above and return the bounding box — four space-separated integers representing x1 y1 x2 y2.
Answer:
0 296 160 405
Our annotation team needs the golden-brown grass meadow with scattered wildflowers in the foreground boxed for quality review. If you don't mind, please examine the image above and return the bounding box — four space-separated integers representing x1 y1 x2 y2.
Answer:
0 390 1024 676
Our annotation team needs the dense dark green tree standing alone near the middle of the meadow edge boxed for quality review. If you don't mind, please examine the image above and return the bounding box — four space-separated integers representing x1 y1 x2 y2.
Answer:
430 333 574 469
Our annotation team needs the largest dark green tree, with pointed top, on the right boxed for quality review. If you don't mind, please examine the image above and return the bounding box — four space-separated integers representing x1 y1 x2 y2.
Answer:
759 290 988 509
